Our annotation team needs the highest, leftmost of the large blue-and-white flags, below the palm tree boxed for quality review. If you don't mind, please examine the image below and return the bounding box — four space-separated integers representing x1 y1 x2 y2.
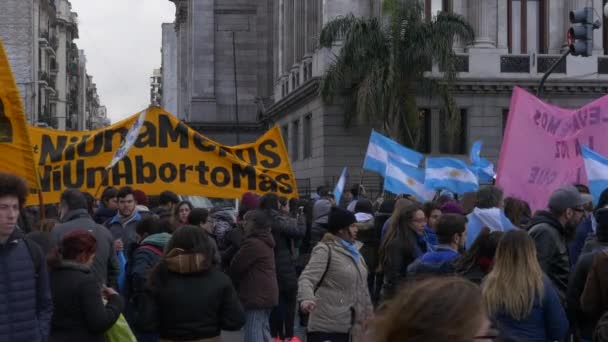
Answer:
363 130 424 176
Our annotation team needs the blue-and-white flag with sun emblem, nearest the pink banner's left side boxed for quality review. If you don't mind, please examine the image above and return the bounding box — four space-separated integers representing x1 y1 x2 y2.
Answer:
424 158 479 194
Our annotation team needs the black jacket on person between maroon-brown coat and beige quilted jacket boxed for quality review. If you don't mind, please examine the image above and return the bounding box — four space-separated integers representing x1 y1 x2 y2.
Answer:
270 210 306 290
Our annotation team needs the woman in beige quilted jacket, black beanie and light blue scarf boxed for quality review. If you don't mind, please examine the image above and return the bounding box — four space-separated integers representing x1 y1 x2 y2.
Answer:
298 207 373 342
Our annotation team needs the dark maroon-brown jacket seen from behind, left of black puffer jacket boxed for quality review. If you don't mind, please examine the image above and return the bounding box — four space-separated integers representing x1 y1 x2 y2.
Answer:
229 231 279 310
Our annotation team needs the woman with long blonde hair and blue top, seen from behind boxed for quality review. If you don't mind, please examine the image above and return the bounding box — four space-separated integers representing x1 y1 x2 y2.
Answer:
482 230 568 342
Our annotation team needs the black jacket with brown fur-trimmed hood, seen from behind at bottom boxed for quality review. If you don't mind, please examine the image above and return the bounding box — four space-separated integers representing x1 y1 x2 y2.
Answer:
135 249 245 341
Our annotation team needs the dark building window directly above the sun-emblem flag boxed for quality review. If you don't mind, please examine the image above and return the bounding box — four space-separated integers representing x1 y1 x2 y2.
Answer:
439 109 467 154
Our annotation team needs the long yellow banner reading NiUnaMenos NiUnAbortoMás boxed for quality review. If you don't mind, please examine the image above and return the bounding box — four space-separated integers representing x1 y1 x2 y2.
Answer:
30 107 298 204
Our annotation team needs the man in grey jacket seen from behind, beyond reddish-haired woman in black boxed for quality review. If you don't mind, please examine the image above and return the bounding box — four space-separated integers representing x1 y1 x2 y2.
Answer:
53 189 120 288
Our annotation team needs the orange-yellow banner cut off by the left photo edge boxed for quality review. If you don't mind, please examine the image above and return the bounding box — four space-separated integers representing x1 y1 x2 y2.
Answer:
0 39 40 194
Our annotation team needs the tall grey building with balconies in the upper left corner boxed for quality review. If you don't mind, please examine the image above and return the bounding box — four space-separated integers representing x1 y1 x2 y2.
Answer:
0 0 104 130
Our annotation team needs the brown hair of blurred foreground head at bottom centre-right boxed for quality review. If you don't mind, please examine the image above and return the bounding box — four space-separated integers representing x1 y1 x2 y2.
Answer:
370 277 485 342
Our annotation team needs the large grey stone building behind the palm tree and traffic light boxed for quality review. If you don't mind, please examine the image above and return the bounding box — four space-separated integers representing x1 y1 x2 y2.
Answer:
167 0 608 198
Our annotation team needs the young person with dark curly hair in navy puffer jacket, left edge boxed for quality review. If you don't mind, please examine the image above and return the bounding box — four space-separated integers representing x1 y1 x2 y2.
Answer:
0 172 53 342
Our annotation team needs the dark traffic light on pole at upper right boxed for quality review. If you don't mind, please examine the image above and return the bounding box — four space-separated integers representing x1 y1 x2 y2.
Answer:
568 7 602 57
